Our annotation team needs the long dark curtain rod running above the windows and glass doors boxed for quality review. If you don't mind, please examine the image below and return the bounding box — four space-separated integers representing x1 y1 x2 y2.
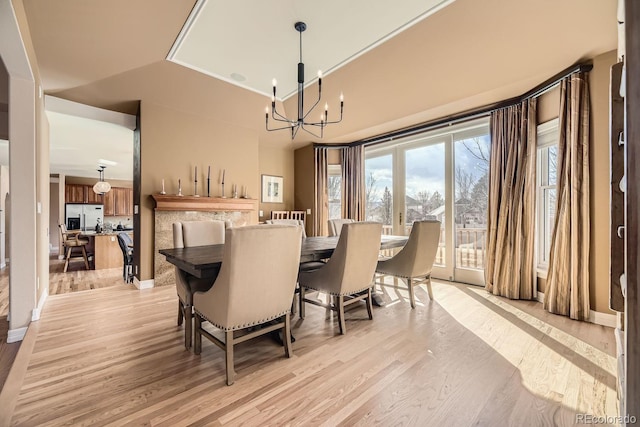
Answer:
313 62 593 148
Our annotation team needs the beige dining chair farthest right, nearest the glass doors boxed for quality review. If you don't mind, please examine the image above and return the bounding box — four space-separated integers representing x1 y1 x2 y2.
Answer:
376 221 440 308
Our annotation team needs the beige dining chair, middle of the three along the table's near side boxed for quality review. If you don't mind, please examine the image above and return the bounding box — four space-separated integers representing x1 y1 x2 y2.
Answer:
298 222 382 334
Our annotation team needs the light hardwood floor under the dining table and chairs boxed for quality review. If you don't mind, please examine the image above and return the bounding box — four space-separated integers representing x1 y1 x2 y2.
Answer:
0 281 616 426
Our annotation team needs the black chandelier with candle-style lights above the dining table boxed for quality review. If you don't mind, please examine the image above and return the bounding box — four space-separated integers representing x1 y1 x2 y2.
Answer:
265 22 344 139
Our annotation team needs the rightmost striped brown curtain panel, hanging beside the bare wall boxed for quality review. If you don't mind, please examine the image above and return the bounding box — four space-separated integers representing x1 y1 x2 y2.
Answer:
544 73 590 320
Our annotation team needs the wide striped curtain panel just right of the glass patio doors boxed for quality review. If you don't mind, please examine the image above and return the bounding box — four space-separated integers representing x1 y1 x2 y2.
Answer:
484 99 537 299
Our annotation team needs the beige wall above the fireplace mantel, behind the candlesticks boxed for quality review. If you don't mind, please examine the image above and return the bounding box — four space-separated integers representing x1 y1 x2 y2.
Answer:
136 100 264 280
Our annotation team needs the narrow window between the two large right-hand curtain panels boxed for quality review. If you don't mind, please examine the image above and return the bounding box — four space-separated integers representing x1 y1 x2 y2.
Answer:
536 119 558 272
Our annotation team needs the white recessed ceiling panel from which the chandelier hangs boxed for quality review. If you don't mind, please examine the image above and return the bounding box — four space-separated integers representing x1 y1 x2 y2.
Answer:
167 0 454 100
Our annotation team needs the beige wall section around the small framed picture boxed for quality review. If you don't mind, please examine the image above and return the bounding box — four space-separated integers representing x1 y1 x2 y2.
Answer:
258 145 296 221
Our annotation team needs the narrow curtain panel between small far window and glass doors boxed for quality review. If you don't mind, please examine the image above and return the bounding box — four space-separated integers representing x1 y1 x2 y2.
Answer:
342 145 365 221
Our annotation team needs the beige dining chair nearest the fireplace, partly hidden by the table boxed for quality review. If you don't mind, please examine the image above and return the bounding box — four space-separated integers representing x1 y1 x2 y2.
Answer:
173 220 231 349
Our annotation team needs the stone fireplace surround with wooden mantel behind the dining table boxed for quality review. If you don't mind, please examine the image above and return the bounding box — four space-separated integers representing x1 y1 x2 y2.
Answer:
153 194 258 286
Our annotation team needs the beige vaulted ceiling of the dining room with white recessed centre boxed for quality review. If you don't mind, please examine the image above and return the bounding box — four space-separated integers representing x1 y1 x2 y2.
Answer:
24 0 617 154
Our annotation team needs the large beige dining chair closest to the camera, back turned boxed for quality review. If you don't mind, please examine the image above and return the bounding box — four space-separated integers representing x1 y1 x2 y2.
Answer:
193 225 302 385
